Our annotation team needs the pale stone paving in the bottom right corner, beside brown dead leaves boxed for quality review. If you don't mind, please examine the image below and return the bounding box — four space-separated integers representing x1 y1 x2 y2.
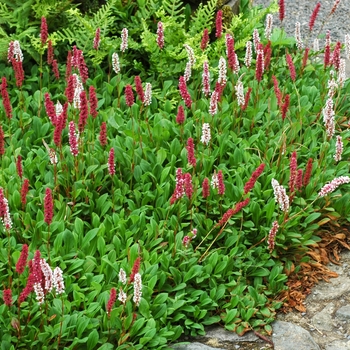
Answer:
173 251 350 350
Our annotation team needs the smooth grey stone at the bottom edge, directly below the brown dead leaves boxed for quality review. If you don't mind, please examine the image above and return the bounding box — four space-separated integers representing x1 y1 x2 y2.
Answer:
272 321 320 350
